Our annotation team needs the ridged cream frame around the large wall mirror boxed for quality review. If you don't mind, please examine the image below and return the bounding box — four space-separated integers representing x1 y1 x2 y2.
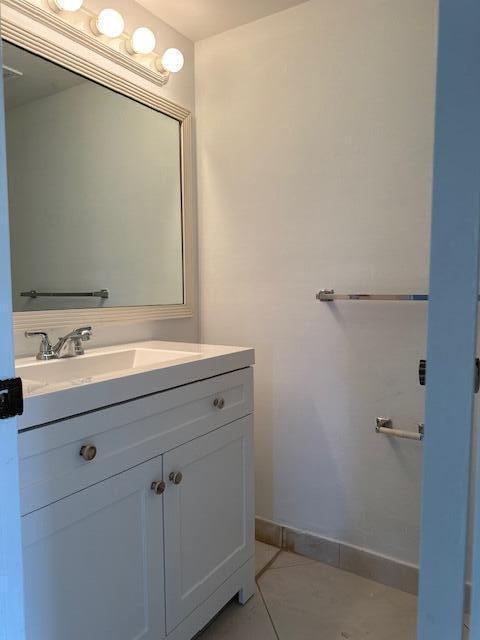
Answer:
1 0 195 331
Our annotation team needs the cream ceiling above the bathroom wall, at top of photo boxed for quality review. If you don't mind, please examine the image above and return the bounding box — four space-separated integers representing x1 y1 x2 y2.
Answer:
137 0 306 41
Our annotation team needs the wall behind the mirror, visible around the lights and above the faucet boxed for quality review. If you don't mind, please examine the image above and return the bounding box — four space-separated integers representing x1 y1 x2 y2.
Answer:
2 0 199 355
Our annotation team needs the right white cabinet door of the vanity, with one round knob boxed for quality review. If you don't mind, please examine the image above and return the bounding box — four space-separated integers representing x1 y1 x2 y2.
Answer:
164 416 254 633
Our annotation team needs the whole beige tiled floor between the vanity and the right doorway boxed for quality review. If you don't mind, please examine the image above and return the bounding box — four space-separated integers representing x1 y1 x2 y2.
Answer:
199 543 468 640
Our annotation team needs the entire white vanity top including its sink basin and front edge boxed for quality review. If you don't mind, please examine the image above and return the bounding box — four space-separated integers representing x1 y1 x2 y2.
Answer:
15 340 254 431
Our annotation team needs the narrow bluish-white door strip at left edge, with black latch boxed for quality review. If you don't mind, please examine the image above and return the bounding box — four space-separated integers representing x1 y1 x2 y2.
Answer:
0 33 25 640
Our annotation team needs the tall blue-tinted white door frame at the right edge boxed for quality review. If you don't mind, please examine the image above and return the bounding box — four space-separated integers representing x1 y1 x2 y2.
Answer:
417 0 480 640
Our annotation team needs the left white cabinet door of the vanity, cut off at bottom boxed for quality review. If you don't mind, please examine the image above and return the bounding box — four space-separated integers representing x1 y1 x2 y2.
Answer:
22 457 165 640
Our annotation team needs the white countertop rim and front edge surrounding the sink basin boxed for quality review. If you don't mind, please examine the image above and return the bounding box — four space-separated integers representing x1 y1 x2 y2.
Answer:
15 340 255 430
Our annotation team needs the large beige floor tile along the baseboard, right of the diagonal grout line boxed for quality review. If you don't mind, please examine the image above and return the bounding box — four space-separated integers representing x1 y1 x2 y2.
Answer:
259 562 417 640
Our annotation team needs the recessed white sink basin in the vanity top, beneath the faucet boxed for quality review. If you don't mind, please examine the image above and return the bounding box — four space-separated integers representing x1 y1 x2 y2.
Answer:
16 348 201 394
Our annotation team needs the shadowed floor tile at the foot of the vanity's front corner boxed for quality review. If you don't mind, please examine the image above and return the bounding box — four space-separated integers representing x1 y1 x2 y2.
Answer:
197 590 277 640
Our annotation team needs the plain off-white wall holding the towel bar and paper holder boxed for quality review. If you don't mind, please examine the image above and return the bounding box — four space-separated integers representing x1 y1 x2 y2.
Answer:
196 0 436 563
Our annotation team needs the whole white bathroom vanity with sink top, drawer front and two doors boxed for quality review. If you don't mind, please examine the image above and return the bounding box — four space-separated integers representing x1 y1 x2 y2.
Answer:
16 342 255 640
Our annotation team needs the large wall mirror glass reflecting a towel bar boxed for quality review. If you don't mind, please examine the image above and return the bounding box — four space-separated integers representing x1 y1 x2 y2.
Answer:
3 30 191 326
